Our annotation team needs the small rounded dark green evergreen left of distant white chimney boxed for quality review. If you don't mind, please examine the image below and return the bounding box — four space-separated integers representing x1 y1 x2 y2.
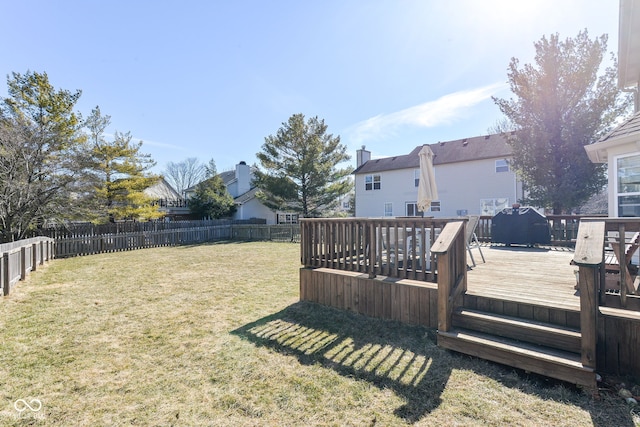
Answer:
189 175 236 219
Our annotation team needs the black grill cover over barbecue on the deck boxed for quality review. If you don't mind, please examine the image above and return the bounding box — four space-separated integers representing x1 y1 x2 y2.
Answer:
491 208 551 246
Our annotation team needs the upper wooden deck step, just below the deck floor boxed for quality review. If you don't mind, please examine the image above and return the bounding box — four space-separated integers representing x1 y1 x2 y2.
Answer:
453 308 581 353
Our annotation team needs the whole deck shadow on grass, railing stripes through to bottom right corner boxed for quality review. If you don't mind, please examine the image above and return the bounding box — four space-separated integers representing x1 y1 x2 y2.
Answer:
231 302 634 426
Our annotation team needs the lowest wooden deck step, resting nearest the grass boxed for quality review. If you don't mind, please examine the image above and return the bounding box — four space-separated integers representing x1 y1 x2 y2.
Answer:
438 328 596 390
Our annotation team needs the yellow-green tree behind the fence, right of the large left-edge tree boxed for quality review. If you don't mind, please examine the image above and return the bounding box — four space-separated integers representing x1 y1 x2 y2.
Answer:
85 107 162 222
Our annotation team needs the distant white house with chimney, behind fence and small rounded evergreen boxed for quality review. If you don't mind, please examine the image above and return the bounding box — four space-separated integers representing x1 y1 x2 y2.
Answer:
185 161 298 224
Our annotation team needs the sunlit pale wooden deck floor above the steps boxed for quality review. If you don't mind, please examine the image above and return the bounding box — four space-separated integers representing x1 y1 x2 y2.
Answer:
467 245 580 311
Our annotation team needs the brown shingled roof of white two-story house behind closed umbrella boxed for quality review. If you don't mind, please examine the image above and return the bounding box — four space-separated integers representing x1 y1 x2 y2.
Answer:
353 134 512 174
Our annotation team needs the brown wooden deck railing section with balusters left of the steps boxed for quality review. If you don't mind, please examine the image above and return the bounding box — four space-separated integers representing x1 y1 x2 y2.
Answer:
300 217 451 282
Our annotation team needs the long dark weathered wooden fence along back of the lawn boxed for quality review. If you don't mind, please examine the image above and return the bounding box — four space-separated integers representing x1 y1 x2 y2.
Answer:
55 223 300 258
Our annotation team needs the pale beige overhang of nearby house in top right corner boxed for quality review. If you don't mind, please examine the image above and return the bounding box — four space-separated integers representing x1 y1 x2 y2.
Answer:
618 0 640 88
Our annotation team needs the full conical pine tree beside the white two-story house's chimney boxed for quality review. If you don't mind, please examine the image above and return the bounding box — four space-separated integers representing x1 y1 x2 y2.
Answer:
255 114 352 217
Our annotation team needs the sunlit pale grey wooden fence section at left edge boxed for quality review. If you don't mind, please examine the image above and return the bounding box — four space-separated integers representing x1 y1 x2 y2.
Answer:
0 237 55 295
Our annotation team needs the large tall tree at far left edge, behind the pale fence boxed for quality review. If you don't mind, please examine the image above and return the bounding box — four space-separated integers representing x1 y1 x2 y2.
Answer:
0 71 86 241
